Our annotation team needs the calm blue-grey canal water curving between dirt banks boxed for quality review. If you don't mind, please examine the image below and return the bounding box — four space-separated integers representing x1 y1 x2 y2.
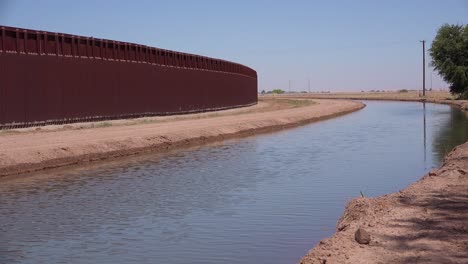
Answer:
0 101 468 264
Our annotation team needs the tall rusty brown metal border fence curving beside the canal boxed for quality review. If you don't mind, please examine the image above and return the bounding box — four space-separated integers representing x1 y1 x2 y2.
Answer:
0 27 257 129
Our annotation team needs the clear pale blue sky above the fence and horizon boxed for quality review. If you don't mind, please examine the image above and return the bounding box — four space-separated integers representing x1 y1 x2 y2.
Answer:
0 0 468 91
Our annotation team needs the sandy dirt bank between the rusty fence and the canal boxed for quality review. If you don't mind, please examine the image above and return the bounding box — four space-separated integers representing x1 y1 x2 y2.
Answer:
0 99 364 176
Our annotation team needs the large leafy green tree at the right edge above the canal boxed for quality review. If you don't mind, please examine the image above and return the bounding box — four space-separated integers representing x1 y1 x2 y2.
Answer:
429 24 468 99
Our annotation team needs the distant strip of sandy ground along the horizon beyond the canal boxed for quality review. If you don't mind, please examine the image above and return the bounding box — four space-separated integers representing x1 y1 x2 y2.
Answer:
262 91 468 110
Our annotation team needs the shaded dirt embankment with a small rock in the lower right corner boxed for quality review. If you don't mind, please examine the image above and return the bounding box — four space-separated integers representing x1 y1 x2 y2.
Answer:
300 142 468 264
